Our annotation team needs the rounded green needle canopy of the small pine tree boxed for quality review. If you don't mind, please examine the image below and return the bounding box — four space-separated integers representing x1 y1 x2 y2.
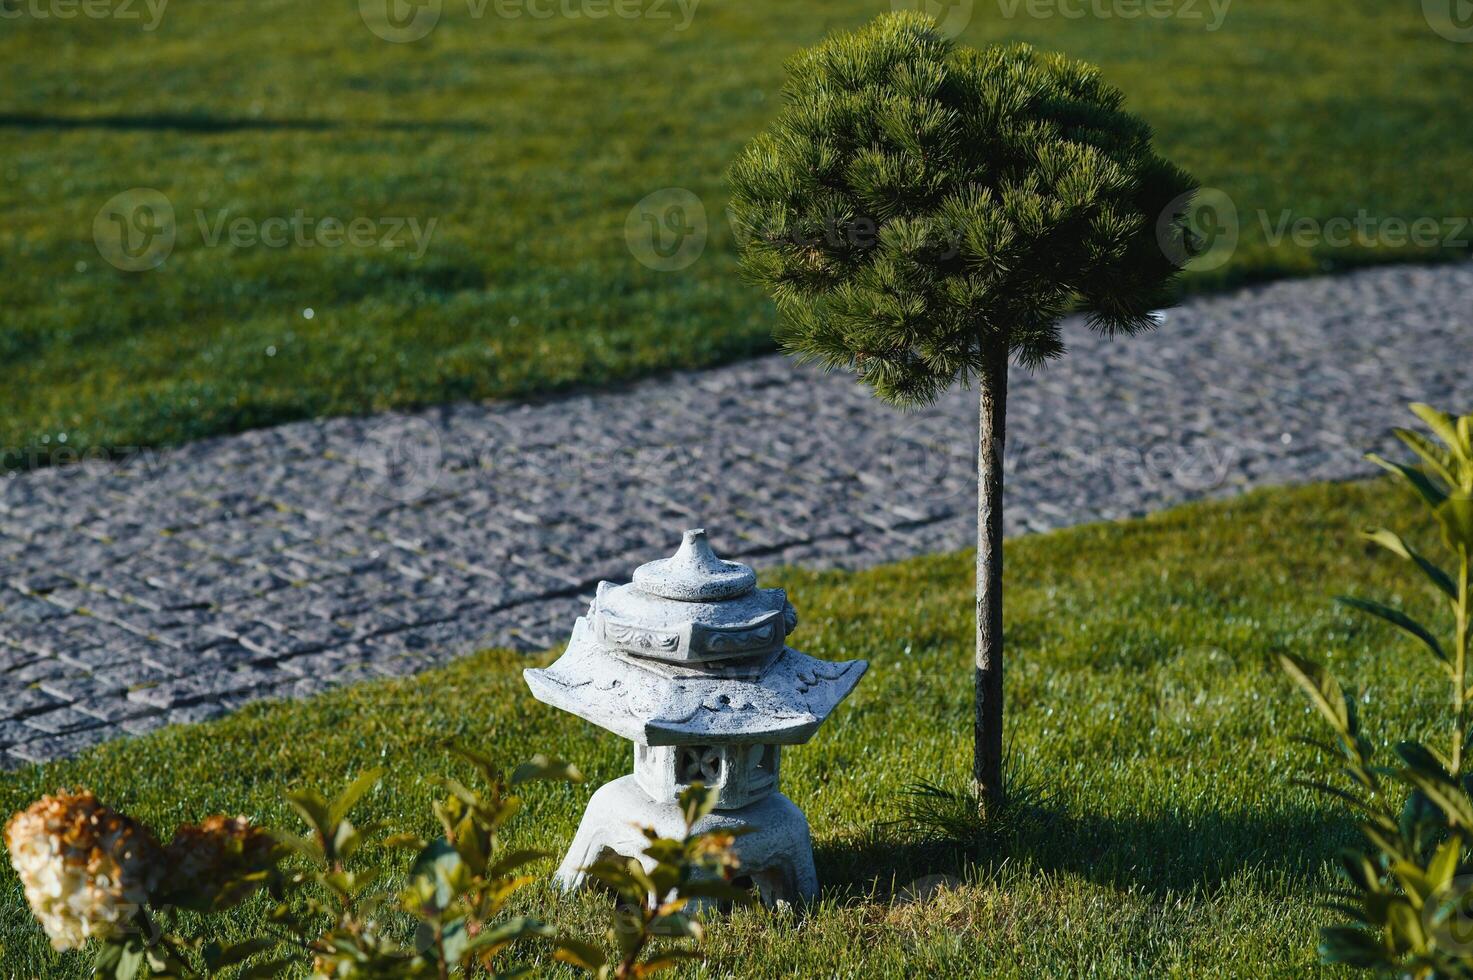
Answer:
729 12 1195 404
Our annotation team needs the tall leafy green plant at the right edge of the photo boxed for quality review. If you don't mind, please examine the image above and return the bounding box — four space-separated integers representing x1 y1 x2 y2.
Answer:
1280 405 1473 977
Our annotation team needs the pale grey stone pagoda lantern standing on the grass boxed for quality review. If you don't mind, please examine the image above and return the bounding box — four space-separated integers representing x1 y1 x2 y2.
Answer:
524 531 869 902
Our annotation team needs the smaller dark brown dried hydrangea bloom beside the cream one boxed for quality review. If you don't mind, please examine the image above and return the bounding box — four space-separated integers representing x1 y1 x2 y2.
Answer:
162 815 277 911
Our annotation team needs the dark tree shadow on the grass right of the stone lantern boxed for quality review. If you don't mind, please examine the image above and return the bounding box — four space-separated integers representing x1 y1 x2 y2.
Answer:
815 806 1357 897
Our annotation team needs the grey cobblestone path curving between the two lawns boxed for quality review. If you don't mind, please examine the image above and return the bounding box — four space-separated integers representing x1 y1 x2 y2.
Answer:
0 264 1473 768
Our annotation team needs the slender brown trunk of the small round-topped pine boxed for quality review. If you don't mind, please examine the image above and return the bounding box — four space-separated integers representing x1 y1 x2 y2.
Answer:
972 348 1008 803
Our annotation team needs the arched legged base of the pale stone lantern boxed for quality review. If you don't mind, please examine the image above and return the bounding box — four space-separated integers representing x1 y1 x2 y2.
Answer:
557 775 819 905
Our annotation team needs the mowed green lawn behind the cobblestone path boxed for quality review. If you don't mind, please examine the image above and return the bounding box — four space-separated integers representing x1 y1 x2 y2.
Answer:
0 0 1473 467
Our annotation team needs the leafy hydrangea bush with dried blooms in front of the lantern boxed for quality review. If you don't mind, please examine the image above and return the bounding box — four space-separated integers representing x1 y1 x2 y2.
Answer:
6 749 745 980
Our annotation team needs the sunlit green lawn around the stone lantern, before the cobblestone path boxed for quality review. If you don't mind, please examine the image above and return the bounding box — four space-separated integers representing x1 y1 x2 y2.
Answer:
0 482 1439 979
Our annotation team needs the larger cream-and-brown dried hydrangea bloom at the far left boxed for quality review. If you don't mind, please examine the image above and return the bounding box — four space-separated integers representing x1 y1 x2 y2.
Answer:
4 790 159 949
